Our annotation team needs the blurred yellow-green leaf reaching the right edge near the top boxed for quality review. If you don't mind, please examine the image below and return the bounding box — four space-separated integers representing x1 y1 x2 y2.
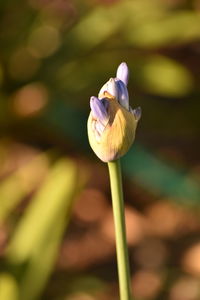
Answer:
126 11 200 48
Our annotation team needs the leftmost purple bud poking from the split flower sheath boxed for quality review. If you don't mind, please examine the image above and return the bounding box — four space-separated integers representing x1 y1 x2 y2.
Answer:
90 96 109 124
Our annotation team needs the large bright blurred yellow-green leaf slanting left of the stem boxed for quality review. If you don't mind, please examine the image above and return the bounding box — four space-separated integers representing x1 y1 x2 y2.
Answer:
8 159 77 263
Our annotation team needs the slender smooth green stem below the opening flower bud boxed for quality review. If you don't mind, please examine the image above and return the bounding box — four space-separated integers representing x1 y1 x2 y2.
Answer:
108 160 131 300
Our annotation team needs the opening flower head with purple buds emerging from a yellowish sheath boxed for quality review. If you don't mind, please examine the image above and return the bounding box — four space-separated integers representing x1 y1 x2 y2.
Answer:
88 62 141 162
